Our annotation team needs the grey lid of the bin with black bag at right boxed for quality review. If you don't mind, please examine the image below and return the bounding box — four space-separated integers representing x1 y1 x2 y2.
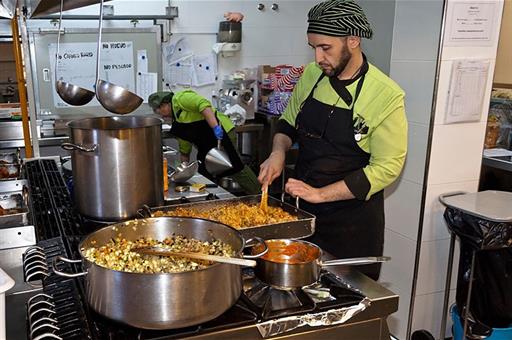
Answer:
439 190 512 222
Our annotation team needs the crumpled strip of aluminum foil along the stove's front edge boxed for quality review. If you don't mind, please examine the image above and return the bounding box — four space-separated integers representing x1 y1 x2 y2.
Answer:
256 297 371 338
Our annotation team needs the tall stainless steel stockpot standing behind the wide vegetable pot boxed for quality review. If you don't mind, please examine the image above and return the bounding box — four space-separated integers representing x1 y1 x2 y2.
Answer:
62 116 163 221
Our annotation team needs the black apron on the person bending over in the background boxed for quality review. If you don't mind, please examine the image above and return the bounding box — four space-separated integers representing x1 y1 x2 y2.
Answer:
170 111 244 179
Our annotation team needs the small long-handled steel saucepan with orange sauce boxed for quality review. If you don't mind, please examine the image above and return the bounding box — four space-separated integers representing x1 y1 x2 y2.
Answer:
252 239 391 288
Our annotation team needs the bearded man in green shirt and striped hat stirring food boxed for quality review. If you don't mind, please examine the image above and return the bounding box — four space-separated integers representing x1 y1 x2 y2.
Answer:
258 0 407 280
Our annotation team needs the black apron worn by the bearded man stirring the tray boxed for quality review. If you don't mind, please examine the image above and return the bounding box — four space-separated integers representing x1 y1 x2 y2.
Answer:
295 74 384 279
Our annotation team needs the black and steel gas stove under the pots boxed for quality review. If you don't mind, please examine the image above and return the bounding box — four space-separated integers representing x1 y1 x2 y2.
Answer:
0 160 398 340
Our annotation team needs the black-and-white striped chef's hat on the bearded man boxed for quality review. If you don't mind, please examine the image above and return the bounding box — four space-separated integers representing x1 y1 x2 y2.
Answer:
308 0 373 39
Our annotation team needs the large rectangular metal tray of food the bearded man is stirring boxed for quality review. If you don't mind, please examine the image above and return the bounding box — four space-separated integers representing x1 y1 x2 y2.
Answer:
149 195 315 240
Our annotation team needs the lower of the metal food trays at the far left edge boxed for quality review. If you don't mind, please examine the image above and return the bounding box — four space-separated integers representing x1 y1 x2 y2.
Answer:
0 193 29 228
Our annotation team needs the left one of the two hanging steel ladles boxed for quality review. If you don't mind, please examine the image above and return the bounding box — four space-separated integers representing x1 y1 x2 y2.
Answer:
55 0 94 106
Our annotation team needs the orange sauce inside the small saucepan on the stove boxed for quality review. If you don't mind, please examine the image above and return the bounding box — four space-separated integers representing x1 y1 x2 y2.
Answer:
254 240 320 264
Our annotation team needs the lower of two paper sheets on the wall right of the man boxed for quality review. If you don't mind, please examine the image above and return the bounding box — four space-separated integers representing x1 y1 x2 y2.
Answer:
445 60 489 124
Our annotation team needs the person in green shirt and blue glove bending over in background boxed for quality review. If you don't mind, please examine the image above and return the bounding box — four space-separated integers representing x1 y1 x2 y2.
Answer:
148 90 260 194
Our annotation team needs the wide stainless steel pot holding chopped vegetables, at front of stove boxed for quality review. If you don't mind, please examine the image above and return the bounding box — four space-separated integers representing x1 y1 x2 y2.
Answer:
53 217 266 329
